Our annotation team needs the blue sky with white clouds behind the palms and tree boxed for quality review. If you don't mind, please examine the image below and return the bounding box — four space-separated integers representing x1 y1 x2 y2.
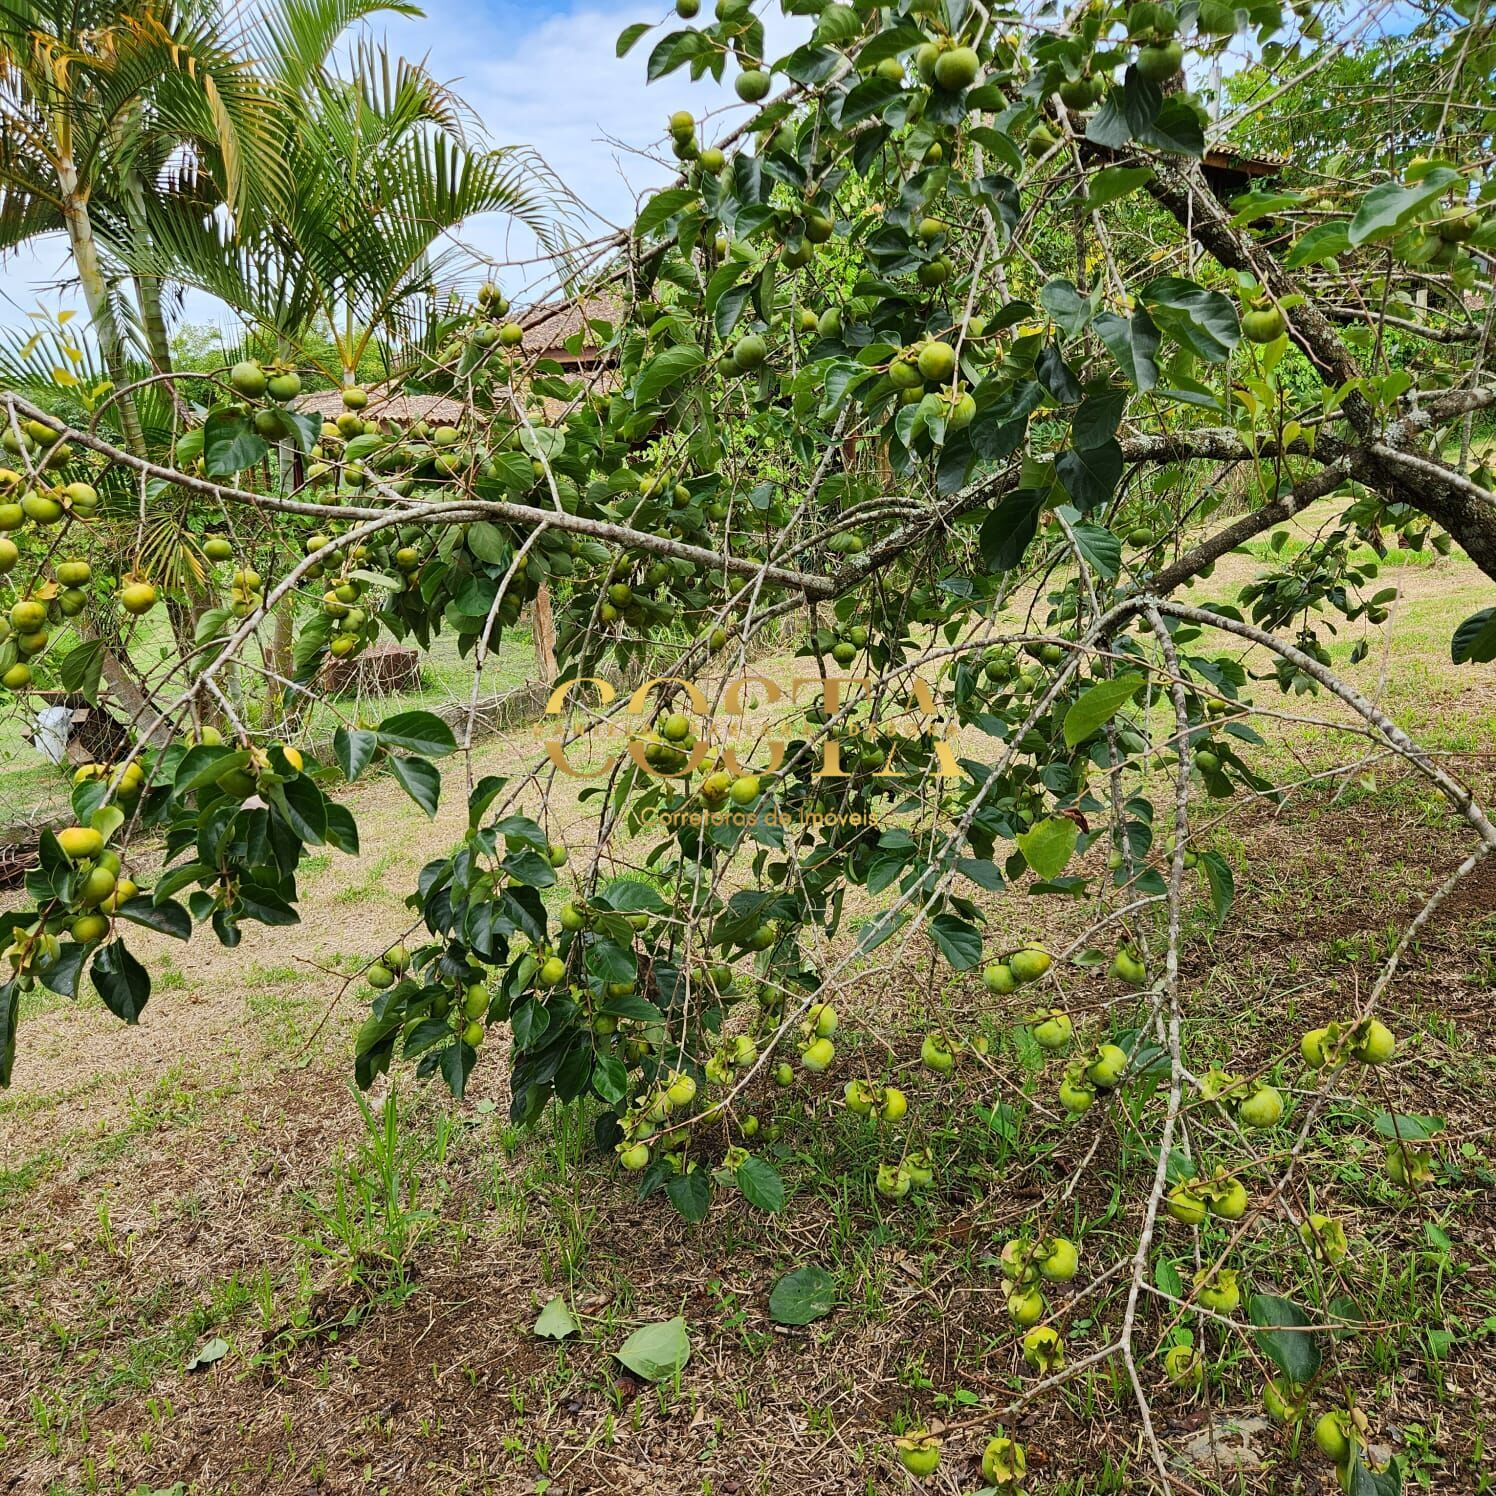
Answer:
0 0 813 336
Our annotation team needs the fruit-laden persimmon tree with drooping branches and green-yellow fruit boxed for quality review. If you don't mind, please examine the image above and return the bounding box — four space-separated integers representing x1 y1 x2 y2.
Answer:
0 0 1496 1492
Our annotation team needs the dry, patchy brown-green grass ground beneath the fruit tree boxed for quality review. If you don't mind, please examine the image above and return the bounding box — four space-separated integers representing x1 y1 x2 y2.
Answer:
0 544 1496 1496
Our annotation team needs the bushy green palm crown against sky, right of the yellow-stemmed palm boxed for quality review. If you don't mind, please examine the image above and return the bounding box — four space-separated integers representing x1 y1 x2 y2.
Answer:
136 45 571 383
